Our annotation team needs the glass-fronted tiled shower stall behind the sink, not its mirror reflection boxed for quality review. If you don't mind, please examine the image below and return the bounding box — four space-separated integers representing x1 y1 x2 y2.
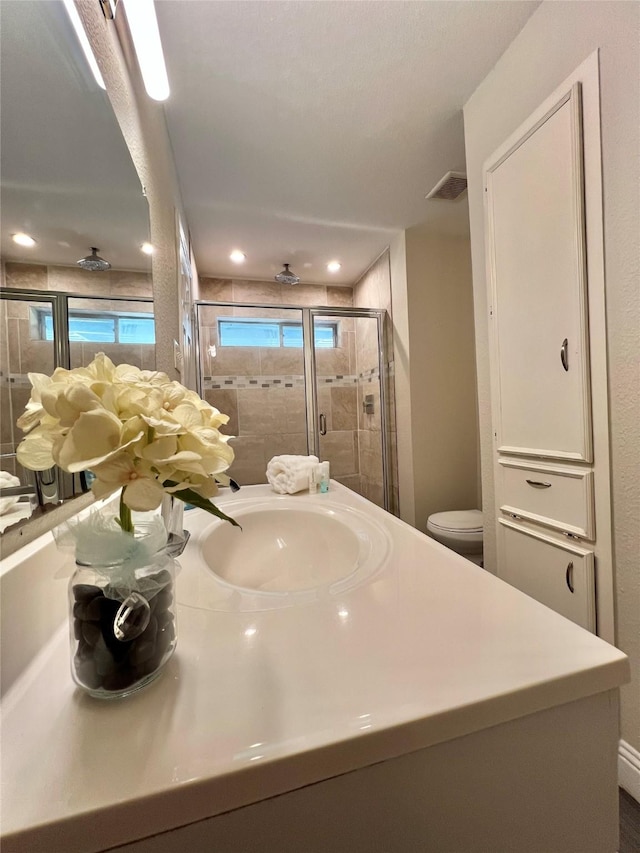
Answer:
195 301 393 510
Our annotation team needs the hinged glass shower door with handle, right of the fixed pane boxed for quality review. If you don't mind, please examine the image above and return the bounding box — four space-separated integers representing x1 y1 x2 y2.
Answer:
311 309 388 508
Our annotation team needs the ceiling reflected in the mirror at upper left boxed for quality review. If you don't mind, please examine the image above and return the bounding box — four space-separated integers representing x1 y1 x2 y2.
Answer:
0 0 150 275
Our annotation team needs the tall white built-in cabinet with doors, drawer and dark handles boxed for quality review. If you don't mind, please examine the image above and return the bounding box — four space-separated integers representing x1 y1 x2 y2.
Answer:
484 54 615 642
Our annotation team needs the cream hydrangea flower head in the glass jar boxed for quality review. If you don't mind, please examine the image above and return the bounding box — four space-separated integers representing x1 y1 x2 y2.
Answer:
17 353 235 527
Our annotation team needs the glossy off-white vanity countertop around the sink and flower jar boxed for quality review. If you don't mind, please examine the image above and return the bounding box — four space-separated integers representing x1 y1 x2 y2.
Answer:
1 482 629 853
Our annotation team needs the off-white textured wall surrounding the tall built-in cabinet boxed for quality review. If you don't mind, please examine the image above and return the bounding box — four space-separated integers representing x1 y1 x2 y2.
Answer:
464 0 640 749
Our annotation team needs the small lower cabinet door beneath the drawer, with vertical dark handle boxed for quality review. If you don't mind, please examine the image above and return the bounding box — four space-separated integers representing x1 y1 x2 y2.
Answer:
498 518 596 633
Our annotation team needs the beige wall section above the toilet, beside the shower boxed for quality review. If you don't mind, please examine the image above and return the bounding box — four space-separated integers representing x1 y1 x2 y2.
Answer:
391 226 478 532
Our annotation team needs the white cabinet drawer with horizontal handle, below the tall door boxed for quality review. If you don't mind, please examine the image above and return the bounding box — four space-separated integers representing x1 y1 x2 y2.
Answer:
499 459 595 540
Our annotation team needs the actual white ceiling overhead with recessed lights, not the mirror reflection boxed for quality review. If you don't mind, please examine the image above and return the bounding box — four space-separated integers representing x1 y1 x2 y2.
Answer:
156 0 539 284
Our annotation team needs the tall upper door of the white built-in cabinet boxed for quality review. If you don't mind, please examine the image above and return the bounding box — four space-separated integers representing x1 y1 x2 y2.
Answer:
486 85 592 461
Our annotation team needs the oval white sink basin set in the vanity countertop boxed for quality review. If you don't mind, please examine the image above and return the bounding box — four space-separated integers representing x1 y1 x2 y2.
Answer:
200 497 389 597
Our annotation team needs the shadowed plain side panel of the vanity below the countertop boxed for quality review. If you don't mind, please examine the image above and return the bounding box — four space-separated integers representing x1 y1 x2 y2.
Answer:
118 690 618 853
